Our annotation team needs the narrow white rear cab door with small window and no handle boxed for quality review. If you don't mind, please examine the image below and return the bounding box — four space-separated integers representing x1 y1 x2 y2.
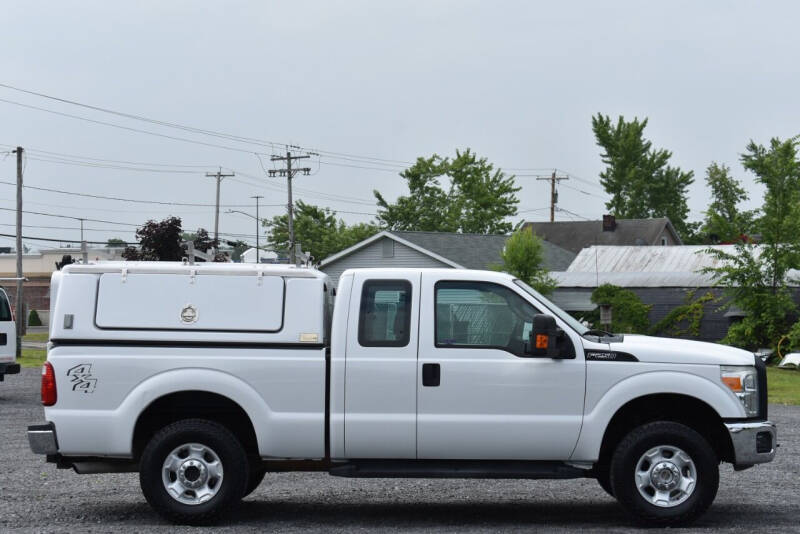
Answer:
344 271 420 458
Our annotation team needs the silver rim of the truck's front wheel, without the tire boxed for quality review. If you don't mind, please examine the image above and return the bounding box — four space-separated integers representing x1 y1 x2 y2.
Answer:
634 445 697 508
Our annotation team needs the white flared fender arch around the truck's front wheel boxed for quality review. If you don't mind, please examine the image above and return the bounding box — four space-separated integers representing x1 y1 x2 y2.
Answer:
570 370 745 462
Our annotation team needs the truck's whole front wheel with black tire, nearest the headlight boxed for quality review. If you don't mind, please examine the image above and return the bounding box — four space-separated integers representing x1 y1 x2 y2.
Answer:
610 421 719 526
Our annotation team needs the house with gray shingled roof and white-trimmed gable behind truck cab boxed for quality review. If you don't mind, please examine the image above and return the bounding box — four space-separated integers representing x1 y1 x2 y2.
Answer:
319 230 575 286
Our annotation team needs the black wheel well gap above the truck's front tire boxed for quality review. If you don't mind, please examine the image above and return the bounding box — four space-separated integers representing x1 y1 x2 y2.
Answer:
598 393 733 465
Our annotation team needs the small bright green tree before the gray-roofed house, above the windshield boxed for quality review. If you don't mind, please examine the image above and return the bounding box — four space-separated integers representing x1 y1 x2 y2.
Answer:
495 227 556 295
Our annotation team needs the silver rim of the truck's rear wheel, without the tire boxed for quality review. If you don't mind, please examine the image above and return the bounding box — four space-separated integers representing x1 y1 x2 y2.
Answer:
161 443 223 505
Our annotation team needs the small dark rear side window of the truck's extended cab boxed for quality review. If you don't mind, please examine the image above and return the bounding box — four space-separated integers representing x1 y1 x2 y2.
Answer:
358 280 411 347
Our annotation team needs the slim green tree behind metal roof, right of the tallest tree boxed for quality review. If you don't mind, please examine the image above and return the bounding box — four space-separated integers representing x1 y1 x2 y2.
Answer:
701 162 755 243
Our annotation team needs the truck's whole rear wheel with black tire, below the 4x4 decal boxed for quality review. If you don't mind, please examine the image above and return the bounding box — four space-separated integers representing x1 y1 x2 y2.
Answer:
139 419 249 525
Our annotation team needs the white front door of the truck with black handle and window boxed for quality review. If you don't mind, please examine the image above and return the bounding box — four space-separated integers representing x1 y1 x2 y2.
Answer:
417 270 586 460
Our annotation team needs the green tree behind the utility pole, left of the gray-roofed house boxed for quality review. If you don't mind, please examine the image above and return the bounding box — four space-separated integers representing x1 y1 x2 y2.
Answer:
263 200 379 262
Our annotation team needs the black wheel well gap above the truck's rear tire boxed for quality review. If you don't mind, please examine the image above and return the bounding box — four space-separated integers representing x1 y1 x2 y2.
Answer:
133 391 258 461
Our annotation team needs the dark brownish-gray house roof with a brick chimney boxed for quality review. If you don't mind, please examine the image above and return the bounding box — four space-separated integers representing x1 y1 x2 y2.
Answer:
525 215 683 254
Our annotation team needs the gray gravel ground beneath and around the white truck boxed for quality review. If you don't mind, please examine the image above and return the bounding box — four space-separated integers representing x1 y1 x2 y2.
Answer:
0 369 800 533
